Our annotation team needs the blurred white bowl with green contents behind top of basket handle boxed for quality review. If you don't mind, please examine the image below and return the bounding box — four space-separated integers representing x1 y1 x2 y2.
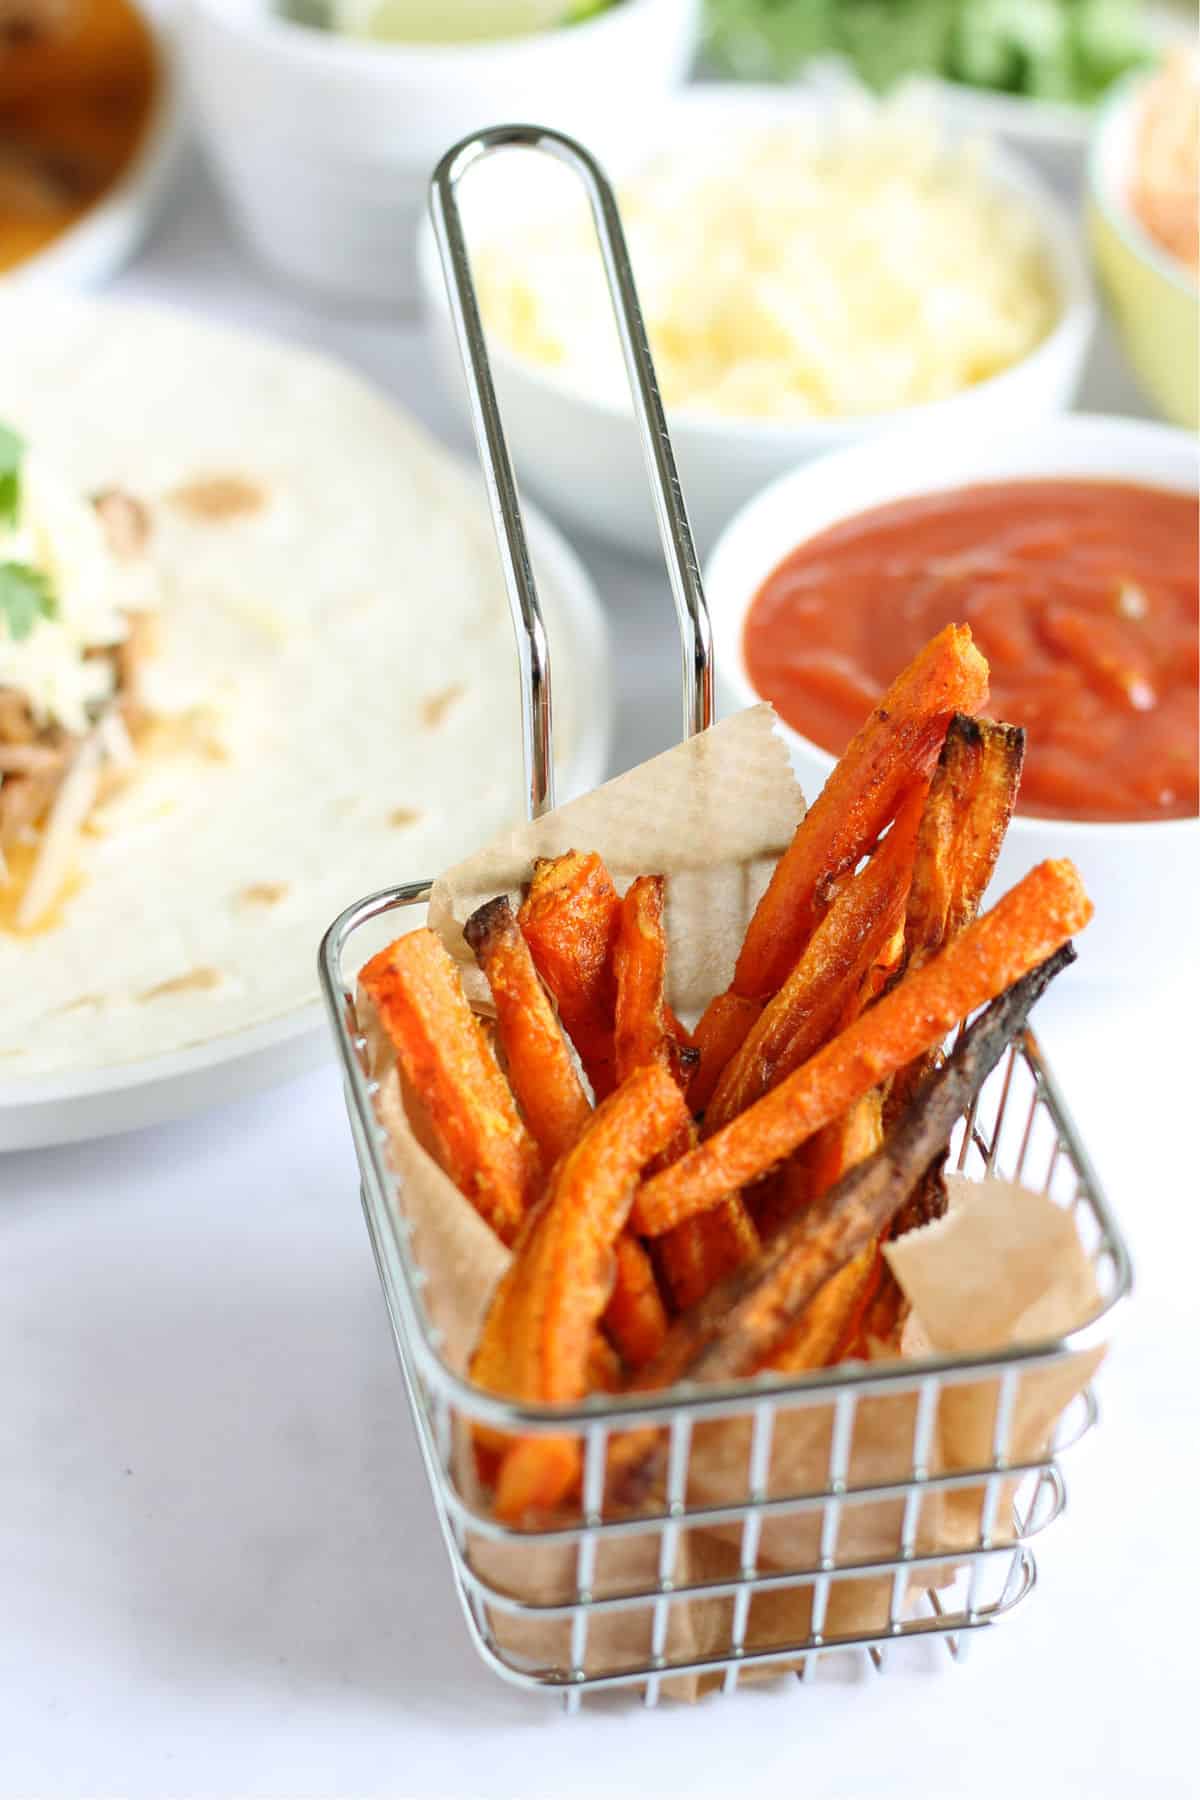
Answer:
182 0 698 306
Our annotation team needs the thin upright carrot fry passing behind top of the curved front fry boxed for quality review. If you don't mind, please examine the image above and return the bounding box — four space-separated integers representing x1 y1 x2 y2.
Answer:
613 875 759 1309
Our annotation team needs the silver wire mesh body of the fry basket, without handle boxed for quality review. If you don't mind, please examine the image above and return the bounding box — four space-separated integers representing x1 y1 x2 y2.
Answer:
327 884 1130 1699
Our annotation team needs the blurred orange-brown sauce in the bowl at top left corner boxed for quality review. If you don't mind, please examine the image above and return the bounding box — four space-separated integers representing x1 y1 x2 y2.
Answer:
0 0 158 270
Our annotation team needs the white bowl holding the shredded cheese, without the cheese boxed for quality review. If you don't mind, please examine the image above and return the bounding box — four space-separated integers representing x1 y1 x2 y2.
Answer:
417 86 1096 554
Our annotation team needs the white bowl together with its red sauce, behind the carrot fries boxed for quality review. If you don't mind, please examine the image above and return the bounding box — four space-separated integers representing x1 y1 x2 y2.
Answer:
705 416 1200 985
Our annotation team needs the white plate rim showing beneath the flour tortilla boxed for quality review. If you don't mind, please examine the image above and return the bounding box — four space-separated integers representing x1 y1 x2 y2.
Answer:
0 506 613 1150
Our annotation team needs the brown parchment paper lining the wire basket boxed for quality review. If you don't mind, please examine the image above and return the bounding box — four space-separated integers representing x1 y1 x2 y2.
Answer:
360 706 1103 1697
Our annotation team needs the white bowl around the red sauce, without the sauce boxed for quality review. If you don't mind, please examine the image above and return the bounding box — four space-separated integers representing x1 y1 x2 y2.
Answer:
705 414 1200 985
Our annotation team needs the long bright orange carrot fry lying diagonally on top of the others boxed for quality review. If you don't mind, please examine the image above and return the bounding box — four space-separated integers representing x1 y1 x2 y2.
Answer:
633 859 1092 1237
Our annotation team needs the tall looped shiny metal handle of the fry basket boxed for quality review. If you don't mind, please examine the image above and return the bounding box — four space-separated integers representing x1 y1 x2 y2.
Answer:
430 124 712 819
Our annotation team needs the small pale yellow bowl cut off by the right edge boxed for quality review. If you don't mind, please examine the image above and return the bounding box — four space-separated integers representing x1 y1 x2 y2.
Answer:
1087 76 1200 430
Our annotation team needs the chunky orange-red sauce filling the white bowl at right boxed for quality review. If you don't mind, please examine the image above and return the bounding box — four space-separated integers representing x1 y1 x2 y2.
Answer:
743 481 1200 821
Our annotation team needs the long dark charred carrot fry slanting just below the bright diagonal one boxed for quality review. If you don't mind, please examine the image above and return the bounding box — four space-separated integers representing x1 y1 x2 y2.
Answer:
631 940 1074 1390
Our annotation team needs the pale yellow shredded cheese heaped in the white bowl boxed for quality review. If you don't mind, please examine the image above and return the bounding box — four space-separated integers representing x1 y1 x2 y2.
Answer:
475 104 1058 419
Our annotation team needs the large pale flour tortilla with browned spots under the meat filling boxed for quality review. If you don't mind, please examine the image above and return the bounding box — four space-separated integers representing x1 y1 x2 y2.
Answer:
0 297 583 1085
